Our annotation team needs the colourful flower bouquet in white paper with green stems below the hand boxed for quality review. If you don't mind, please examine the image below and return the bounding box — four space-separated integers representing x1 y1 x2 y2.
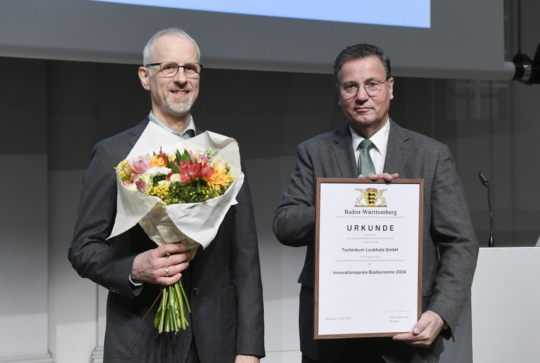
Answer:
109 132 244 333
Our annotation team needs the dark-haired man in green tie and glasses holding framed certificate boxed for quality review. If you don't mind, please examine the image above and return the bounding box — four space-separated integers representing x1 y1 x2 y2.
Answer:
273 44 478 363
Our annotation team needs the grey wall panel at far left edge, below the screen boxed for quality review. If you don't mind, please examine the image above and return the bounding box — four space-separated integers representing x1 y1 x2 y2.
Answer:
0 59 48 358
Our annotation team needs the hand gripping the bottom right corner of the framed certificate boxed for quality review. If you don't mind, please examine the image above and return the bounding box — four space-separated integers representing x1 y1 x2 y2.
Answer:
393 310 444 348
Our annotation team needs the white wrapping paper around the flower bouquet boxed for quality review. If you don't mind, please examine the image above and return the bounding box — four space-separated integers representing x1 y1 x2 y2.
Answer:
107 122 244 258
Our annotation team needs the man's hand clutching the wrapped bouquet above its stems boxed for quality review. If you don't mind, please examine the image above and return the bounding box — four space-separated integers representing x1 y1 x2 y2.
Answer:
131 243 191 286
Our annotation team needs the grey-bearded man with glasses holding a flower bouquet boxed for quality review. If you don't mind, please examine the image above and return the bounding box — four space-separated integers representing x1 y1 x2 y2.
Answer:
69 28 265 363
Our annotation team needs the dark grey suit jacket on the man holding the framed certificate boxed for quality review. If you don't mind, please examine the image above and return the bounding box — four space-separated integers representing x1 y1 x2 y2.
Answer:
273 120 478 362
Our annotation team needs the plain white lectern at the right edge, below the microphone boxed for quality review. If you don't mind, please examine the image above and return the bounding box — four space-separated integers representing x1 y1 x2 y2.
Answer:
471 247 540 363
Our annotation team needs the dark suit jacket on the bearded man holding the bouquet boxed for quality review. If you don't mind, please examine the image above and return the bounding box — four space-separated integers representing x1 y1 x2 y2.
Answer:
69 118 265 363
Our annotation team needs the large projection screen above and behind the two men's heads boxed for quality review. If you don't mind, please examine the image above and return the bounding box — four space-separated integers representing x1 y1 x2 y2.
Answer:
0 0 513 79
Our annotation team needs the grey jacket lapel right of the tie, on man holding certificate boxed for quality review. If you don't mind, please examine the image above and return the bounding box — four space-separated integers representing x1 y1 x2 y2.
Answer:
384 119 409 177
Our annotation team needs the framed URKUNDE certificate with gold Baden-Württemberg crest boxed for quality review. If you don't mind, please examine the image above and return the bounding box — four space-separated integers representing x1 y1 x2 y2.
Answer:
314 178 424 339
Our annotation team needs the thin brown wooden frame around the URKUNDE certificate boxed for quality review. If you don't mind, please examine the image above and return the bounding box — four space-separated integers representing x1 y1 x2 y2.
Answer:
314 178 424 339
